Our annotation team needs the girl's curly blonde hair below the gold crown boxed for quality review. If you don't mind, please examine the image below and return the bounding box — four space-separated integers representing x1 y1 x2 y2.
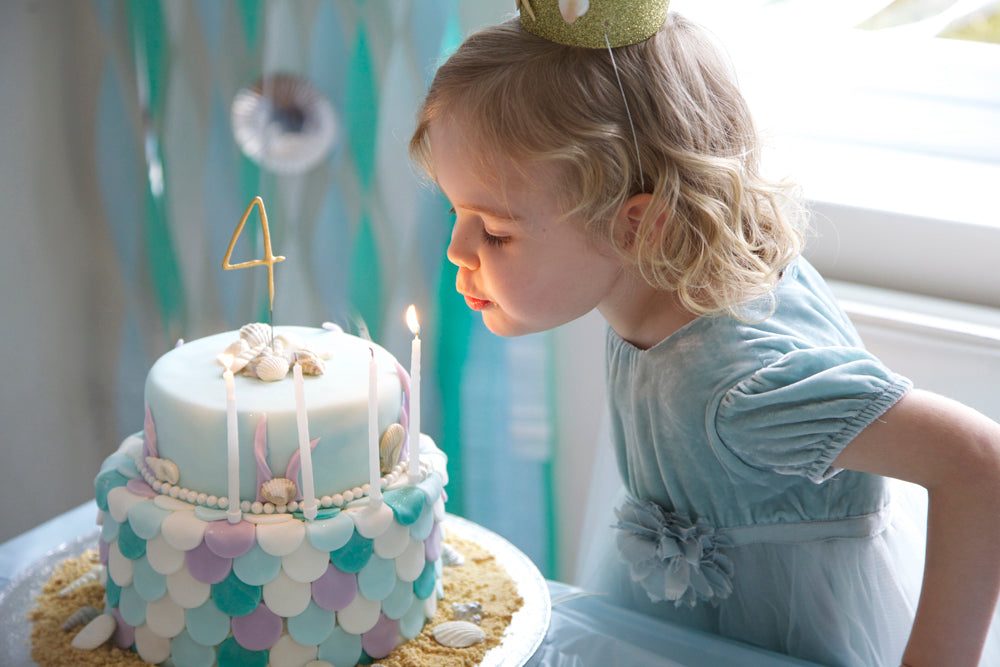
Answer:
410 12 804 315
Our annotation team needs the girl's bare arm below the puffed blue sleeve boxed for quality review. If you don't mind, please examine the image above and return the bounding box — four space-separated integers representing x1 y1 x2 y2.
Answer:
834 390 1000 667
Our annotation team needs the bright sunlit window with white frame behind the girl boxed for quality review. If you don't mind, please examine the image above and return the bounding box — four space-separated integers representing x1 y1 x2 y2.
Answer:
671 0 1000 306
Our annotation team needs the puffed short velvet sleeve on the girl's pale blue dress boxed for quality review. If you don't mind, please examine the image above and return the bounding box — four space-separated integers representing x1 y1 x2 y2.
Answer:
715 347 912 482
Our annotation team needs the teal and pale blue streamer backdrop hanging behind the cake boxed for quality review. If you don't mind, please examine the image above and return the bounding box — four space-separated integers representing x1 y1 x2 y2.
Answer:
93 0 558 576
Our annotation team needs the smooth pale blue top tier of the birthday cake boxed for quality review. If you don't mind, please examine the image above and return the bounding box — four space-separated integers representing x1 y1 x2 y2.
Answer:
145 326 405 501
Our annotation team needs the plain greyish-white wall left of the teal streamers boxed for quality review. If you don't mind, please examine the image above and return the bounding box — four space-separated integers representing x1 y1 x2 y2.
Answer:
0 0 119 540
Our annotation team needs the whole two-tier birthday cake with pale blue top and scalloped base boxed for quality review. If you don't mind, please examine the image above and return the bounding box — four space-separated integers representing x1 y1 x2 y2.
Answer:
92 327 447 667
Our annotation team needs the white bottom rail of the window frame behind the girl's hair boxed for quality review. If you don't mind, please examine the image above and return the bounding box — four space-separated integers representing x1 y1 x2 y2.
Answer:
768 139 1000 307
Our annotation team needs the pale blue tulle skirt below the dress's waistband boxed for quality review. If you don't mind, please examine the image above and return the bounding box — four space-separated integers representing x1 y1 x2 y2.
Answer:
578 481 1000 667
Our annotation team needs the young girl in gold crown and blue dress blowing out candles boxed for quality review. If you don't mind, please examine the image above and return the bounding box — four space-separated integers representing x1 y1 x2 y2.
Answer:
411 0 1000 667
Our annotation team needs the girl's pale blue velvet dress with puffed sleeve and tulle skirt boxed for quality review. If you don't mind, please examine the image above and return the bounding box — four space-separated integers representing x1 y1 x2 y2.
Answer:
587 259 1000 667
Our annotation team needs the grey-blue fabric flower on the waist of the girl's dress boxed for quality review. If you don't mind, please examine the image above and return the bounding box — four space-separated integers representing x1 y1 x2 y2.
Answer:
615 498 733 607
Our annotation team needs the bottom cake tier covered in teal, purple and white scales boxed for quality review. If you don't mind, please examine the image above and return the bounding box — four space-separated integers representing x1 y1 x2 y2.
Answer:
96 444 445 667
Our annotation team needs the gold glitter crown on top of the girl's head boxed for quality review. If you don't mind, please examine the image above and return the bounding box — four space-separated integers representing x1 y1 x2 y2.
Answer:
517 0 669 49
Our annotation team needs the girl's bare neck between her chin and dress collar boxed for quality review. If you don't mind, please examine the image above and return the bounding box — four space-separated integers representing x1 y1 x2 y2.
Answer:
598 275 698 350
